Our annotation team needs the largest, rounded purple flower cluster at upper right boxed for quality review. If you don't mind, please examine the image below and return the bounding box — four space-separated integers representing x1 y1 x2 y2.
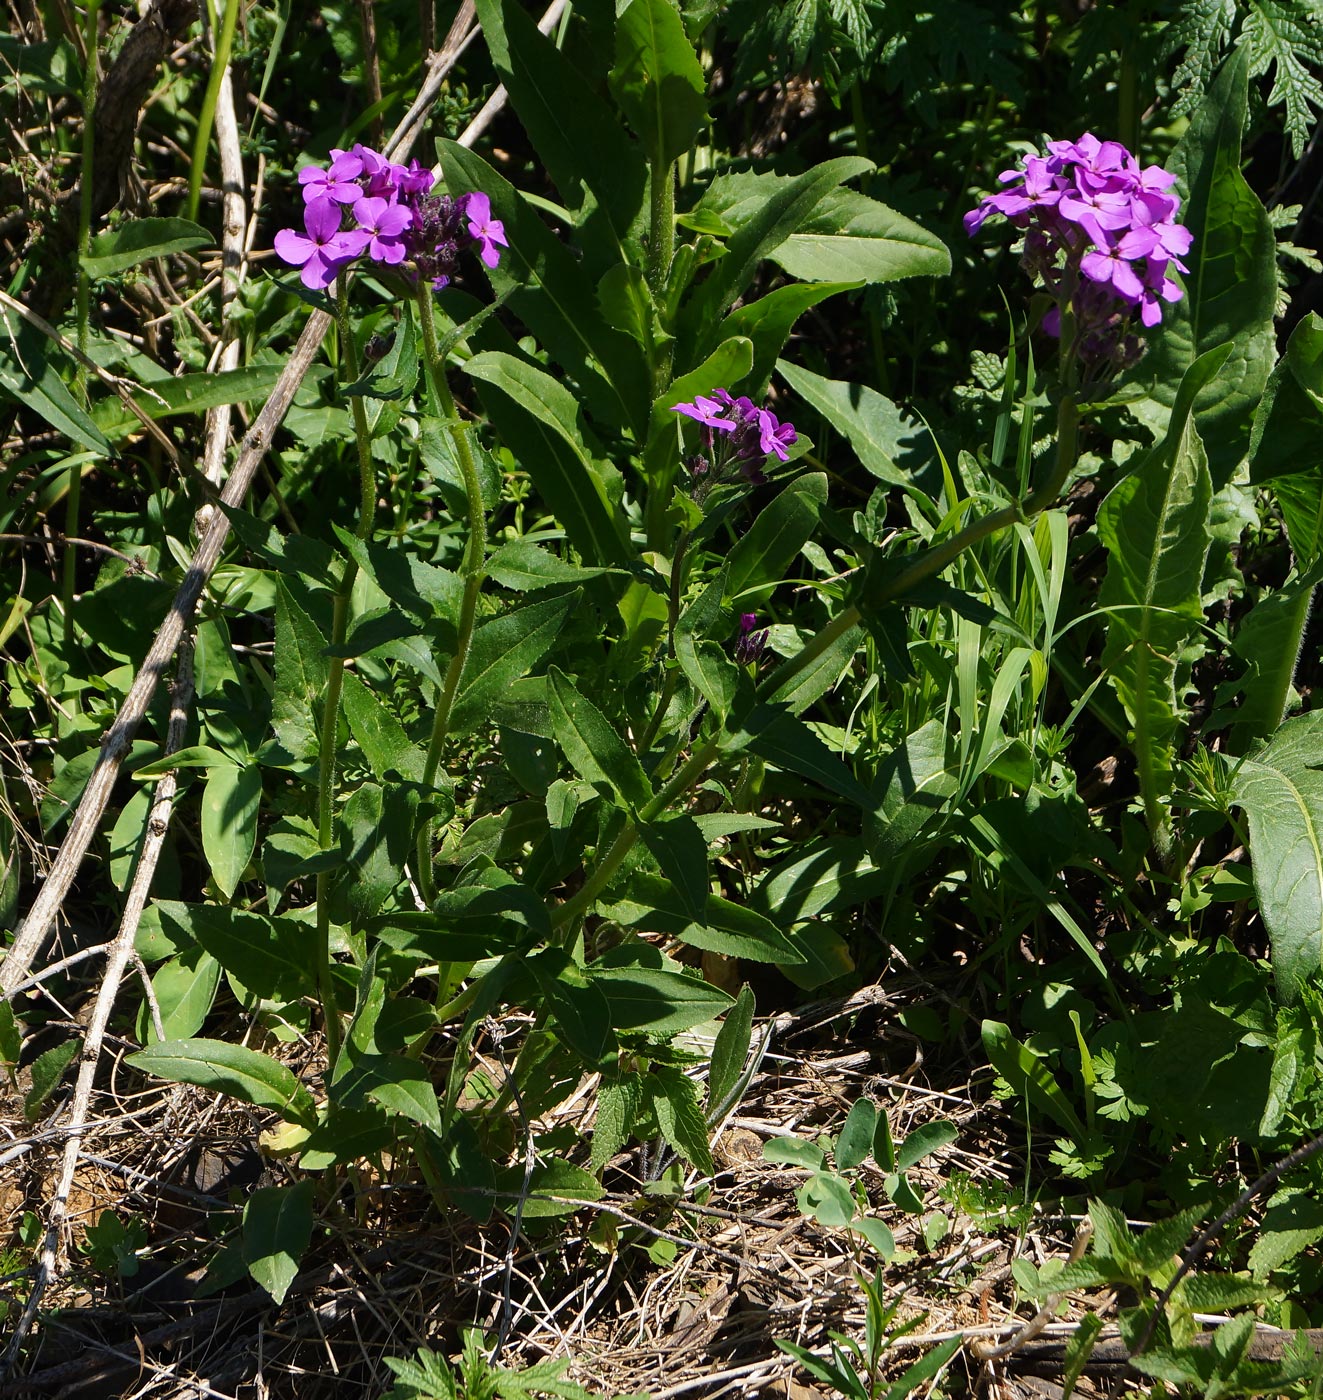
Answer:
965 132 1193 358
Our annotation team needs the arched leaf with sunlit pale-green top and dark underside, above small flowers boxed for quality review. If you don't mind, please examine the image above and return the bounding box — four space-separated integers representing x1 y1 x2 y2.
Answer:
465 350 630 567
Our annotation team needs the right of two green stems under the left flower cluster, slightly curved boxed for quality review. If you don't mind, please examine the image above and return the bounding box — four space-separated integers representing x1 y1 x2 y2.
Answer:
417 283 487 903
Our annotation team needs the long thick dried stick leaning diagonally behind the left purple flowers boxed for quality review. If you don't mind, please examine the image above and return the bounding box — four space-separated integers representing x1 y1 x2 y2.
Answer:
0 21 484 998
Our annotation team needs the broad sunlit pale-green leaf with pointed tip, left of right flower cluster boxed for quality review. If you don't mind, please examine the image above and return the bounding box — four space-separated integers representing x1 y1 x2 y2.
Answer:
771 189 951 283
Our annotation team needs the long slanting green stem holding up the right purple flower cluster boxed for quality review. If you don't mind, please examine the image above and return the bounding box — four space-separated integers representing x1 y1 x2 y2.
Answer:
552 393 1079 934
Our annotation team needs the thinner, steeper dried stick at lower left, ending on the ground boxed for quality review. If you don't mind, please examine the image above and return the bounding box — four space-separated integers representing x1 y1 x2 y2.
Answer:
0 638 193 1378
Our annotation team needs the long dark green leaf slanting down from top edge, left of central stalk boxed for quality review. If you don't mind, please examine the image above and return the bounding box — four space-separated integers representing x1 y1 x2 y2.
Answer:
477 0 647 244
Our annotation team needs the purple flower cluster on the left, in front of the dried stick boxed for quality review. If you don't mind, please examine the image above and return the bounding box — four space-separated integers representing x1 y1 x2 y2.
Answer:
276 146 510 291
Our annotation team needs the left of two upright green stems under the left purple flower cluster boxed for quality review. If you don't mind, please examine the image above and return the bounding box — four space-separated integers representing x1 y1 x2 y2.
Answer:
316 272 377 1065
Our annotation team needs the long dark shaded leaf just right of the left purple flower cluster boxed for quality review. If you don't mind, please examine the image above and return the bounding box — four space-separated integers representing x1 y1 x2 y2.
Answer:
437 141 652 431
